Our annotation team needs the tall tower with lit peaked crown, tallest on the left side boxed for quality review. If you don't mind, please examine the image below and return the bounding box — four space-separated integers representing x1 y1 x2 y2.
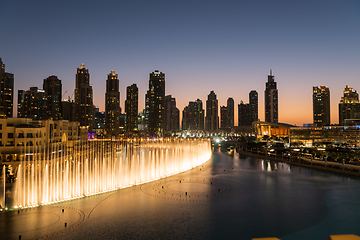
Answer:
74 64 94 131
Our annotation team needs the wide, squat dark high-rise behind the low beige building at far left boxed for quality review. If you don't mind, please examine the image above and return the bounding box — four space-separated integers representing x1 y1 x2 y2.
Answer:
21 87 48 120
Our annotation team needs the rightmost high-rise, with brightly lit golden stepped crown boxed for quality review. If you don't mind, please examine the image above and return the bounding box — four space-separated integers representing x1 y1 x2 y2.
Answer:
339 85 360 125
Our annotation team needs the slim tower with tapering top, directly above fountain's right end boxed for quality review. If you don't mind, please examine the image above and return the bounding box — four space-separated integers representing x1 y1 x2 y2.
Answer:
205 91 219 132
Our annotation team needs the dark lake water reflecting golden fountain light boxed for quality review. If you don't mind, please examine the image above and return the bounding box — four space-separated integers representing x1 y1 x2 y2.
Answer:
0 153 360 240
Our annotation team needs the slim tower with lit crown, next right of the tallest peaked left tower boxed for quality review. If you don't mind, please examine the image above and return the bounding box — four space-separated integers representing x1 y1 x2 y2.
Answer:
105 70 120 136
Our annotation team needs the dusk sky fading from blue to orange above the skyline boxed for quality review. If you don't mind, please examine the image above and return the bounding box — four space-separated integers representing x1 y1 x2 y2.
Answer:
0 0 360 126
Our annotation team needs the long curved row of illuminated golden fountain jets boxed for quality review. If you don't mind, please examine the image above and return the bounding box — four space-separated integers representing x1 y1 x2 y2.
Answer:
9 140 211 208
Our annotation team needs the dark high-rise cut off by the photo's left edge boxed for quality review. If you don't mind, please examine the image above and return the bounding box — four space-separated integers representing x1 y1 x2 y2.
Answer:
0 58 14 117
